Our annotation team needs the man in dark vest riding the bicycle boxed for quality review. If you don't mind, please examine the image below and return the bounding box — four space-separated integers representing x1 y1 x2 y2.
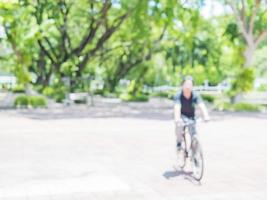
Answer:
174 76 210 152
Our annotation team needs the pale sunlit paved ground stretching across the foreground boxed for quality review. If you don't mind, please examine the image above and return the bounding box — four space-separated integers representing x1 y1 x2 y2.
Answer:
0 108 267 200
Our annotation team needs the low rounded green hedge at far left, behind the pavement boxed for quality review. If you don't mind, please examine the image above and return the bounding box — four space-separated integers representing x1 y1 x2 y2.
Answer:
14 95 47 108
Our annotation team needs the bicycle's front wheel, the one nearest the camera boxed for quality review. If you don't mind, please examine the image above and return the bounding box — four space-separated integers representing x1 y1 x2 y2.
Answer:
191 138 204 181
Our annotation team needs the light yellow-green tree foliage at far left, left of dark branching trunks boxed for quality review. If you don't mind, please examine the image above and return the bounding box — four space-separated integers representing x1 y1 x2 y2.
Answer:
0 1 37 84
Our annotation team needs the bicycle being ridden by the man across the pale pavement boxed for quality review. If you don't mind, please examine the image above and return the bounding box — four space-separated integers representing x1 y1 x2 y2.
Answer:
179 118 204 181
